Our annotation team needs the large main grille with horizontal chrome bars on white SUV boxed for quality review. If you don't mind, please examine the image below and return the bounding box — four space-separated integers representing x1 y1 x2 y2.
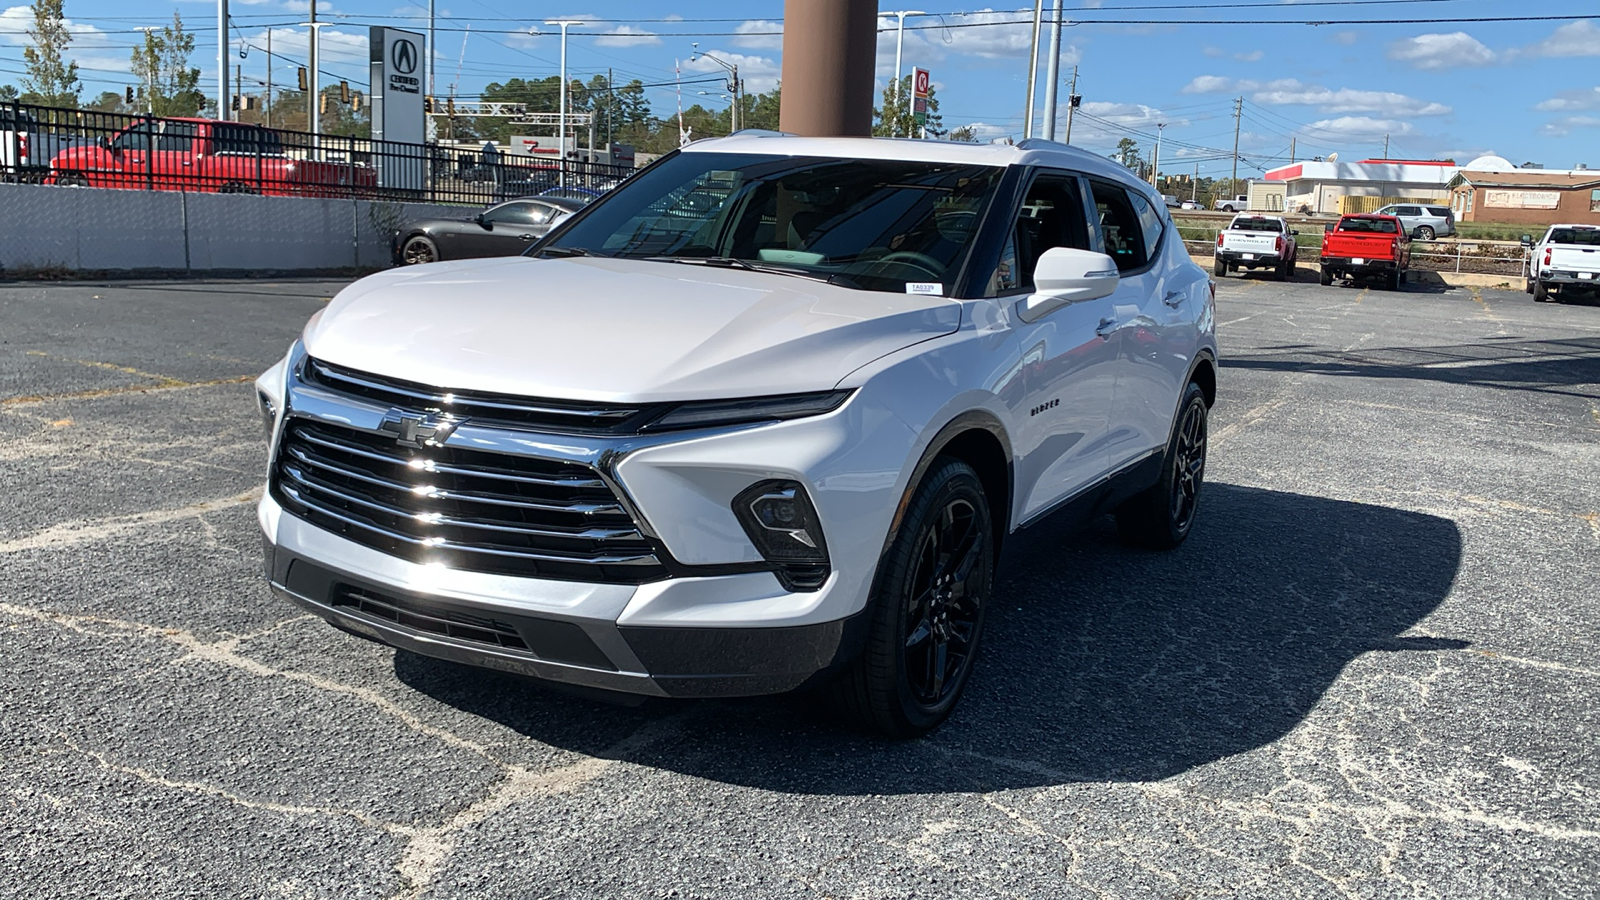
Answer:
272 416 666 585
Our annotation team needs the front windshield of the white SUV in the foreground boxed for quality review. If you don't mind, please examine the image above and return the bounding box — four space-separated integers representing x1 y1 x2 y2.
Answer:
539 152 1002 295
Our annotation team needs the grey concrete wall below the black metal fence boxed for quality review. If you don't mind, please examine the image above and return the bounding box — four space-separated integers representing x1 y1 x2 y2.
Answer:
0 184 472 274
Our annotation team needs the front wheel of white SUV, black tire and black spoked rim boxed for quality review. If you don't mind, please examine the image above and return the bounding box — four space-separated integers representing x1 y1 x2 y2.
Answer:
834 458 994 738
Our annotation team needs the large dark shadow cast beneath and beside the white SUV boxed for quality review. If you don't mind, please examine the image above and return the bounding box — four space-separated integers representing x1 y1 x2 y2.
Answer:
395 484 1466 794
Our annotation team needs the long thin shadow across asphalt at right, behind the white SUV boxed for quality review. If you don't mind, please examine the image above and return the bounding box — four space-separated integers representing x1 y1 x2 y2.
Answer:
1221 338 1600 397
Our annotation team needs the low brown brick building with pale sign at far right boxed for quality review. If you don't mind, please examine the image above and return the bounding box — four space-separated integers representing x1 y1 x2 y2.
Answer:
1450 168 1600 227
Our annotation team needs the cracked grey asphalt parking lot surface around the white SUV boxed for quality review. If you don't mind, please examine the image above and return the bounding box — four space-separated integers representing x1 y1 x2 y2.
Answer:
0 277 1600 898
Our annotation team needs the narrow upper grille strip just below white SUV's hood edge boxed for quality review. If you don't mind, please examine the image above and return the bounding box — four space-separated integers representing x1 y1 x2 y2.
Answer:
302 359 661 434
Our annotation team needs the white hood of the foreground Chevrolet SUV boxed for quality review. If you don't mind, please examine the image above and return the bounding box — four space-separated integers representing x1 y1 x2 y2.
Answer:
306 256 962 402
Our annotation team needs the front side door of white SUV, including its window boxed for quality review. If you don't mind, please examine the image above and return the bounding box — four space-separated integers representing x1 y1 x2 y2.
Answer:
1002 171 1117 519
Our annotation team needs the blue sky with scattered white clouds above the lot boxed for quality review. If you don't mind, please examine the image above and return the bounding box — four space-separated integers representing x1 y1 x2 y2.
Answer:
0 0 1600 176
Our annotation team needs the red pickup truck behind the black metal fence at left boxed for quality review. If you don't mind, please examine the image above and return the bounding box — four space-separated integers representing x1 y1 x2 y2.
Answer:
46 119 378 197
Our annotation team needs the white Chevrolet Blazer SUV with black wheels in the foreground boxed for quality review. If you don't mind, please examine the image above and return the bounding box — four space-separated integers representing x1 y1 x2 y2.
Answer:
258 133 1216 735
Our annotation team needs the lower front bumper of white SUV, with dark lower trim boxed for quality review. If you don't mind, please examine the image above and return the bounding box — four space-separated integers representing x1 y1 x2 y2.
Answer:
262 496 867 697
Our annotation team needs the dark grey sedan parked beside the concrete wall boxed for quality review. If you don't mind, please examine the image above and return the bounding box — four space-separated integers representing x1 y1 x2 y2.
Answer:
394 197 586 266
